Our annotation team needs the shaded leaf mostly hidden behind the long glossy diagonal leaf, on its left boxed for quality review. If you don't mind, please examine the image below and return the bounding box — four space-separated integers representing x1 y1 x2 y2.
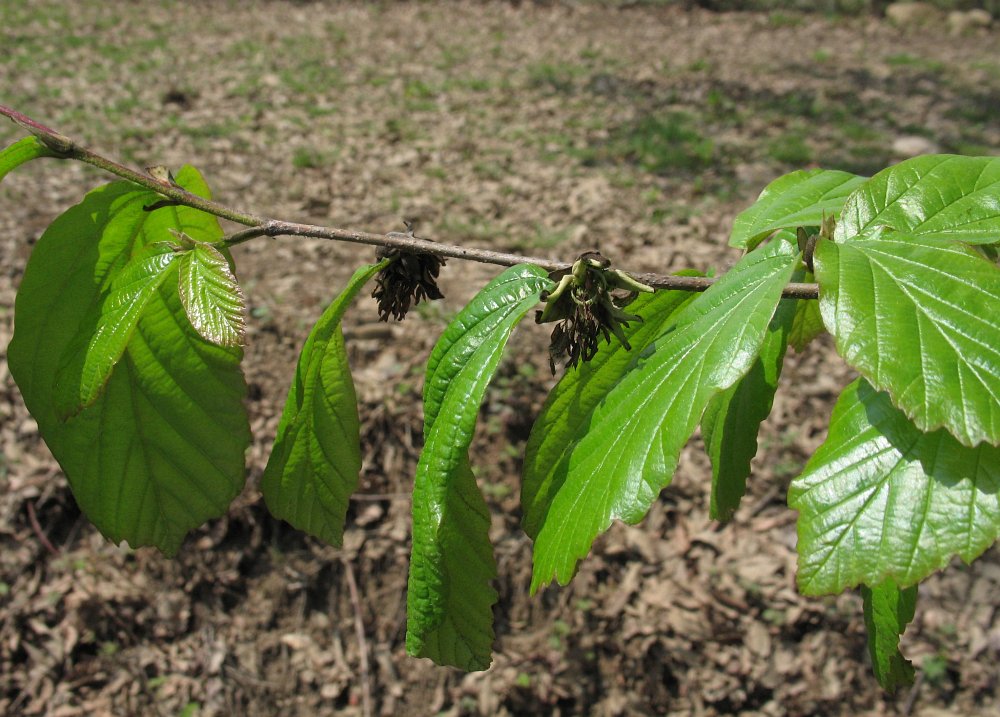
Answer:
521 280 699 538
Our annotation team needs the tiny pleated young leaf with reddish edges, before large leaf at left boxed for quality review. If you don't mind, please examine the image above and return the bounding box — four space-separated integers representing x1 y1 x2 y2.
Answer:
178 242 246 346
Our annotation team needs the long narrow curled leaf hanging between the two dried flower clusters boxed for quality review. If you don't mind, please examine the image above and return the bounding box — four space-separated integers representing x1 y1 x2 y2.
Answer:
406 265 554 670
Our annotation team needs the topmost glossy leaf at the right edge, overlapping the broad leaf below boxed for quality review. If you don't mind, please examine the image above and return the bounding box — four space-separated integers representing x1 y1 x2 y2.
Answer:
834 154 1000 244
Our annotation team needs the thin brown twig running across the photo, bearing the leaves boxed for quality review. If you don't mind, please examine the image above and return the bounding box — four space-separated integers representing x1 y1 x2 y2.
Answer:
0 105 819 299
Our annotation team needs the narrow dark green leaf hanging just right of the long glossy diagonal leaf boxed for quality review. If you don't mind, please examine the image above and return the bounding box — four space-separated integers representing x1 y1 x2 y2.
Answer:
701 299 792 520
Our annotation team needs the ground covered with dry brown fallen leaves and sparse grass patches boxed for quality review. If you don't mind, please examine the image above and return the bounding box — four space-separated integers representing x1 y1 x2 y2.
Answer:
0 0 1000 717
